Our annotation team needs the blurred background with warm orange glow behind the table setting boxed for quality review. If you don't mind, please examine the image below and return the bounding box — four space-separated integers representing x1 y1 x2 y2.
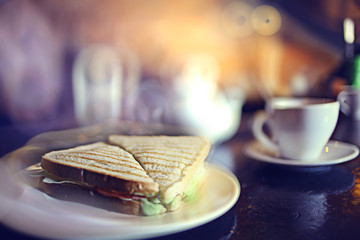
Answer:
0 0 360 152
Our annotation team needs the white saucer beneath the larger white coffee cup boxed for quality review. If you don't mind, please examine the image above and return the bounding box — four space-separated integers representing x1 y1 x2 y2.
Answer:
245 141 359 167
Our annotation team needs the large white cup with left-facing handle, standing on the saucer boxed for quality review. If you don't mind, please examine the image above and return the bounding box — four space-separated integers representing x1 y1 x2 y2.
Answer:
252 98 340 161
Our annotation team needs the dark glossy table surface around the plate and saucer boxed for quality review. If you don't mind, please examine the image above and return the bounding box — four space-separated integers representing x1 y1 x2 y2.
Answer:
0 114 360 239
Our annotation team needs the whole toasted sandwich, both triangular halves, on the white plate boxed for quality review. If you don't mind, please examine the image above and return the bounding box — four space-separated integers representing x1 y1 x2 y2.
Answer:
39 135 210 215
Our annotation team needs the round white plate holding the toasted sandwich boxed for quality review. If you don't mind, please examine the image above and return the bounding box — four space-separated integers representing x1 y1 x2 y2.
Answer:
0 163 240 239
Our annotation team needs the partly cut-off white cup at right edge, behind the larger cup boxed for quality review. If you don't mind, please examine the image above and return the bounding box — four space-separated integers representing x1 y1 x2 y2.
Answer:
338 87 360 120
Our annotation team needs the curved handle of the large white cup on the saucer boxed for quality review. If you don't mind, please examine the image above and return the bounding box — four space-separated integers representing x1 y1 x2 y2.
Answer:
252 111 279 152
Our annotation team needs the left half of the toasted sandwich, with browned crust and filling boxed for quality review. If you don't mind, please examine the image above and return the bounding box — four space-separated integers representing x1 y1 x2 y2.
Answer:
39 142 166 215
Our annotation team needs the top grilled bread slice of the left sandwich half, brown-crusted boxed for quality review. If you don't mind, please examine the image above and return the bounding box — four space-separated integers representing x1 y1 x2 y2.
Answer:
41 142 159 196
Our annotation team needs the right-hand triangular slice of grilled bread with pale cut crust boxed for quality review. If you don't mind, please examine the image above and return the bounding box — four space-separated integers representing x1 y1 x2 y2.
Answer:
108 135 210 211
